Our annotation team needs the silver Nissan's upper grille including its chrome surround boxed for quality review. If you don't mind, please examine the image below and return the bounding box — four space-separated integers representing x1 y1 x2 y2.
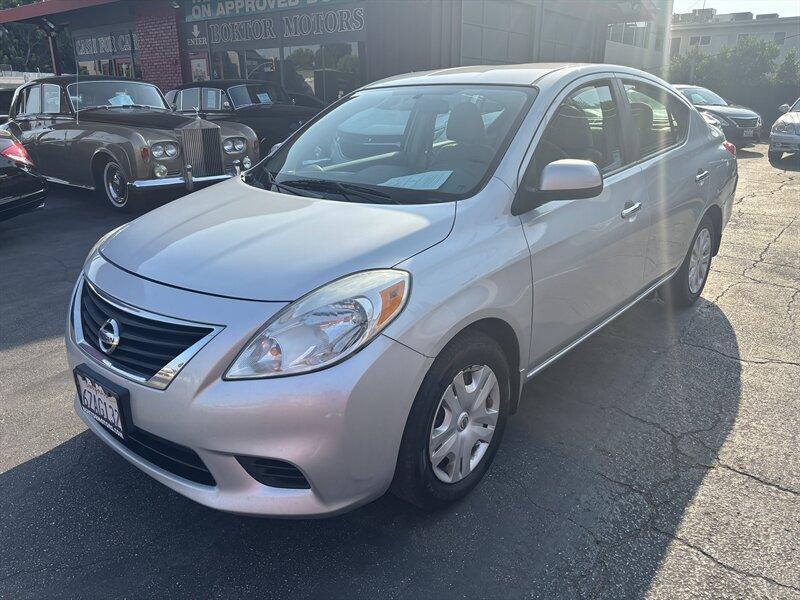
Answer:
73 280 218 389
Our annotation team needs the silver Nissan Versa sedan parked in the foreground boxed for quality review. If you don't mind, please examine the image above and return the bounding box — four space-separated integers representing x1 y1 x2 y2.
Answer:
67 65 737 517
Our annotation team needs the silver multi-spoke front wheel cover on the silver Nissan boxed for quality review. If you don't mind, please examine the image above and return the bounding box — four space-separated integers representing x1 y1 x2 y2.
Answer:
428 365 500 483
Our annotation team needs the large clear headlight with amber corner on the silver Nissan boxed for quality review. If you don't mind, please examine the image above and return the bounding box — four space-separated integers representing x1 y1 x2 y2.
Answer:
225 269 411 379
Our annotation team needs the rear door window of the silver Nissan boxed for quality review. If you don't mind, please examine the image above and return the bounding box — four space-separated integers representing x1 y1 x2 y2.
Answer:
623 81 690 157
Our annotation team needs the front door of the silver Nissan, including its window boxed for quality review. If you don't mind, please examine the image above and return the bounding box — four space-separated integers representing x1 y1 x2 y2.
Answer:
521 78 649 368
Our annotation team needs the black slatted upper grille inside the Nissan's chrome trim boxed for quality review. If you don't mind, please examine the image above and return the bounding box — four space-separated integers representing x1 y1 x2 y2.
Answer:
80 283 213 379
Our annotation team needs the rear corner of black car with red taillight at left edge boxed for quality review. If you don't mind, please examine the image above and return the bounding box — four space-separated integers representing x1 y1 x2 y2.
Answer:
0 129 47 221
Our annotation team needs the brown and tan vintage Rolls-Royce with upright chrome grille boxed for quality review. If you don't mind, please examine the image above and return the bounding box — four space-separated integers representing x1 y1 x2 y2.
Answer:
3 76 258 209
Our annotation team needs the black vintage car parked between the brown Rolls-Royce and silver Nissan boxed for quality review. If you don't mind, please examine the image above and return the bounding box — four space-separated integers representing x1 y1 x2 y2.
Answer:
166 79 322 155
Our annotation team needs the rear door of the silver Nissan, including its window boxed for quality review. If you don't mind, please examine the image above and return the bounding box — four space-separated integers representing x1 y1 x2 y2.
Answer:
619 75 710 283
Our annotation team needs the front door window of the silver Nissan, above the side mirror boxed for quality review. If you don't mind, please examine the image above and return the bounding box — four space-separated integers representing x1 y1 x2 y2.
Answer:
533 82 624 179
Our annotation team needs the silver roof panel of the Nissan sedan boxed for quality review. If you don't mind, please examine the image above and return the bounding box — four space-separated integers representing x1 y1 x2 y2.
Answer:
364 63 648 88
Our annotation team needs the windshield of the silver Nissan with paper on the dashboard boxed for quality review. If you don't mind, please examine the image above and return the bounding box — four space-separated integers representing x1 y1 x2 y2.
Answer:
248 85 535 204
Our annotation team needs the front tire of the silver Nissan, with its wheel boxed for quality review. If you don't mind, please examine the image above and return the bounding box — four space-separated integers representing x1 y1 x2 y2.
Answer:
391 331 511 510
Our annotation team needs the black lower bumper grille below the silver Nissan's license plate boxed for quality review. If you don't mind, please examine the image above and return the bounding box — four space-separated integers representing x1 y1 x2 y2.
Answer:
122 427 217 485
